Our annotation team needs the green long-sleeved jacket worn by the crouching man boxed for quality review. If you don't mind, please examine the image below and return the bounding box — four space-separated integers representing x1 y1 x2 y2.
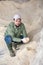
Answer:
5 22 27 42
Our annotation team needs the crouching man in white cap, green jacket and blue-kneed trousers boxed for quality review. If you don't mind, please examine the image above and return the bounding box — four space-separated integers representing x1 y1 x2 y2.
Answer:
5 14 29 57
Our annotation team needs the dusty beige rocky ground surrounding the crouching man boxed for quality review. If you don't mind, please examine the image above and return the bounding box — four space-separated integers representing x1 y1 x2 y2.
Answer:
0 0 43 65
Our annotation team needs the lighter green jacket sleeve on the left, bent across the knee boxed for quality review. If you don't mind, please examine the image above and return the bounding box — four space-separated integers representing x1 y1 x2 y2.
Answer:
5 23 21 42
